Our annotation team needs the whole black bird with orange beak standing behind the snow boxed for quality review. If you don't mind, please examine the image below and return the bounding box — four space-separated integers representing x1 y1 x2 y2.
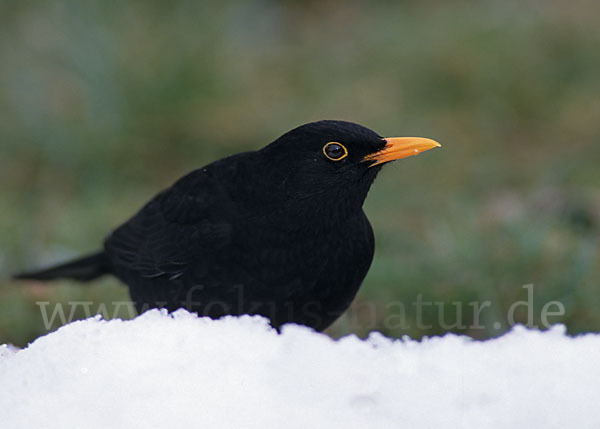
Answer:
15 120 440 331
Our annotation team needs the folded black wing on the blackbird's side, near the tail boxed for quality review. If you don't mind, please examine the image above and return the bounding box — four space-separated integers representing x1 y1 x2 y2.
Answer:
104 170 232 279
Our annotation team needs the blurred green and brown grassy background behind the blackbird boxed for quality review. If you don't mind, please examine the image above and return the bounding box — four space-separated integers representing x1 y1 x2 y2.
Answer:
0 0 600 345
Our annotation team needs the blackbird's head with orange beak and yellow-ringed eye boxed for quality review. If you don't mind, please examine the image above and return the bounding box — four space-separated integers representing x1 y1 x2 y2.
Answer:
254 120 441 219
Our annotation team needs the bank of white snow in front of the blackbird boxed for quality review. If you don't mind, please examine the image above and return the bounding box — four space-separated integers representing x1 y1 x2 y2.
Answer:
0 310 600 429
